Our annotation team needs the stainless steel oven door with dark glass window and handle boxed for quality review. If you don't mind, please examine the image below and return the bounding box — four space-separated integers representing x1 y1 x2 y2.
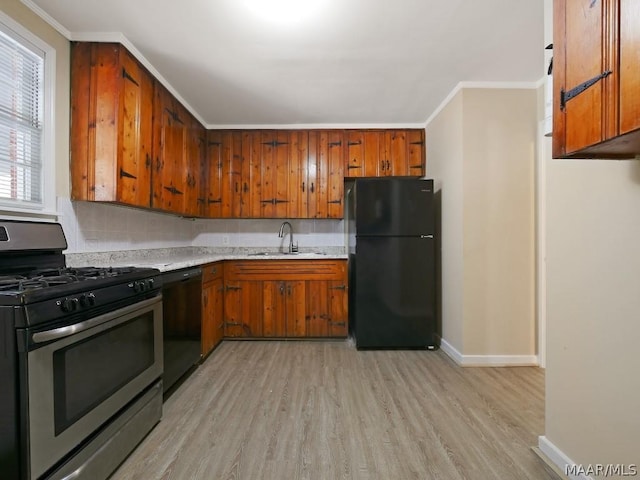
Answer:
27 295 163 478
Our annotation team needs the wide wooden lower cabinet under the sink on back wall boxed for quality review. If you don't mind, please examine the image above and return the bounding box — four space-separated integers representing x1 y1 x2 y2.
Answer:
224 260 348 338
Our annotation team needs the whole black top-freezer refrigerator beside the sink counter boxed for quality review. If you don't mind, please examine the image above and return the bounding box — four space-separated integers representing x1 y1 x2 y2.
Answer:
348 177 440 350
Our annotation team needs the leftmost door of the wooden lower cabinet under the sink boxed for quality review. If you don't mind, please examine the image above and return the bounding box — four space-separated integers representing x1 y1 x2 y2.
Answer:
224 280 266 338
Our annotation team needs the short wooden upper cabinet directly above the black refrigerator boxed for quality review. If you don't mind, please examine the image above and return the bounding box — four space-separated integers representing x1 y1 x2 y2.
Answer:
344 129 425 178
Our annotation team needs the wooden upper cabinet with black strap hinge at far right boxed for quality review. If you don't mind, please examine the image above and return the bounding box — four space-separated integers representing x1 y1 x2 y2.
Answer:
553 0 640 158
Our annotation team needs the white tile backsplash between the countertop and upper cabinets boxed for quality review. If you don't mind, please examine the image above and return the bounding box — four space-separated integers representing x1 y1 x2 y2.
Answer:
58 197 344 253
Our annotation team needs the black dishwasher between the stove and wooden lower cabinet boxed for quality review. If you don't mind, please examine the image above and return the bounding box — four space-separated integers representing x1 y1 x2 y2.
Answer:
162 267 202 393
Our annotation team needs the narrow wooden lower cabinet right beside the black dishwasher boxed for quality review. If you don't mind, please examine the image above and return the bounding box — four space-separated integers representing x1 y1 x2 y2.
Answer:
202 262 224 357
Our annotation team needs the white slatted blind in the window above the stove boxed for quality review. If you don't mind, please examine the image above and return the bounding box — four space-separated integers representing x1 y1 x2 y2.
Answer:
0 25 44 208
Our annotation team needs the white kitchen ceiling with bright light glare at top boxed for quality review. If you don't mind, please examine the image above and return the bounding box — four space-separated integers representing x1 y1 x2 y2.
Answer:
22 0 544 128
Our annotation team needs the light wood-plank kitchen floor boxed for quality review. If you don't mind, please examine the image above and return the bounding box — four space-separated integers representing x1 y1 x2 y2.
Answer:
112 341 556 480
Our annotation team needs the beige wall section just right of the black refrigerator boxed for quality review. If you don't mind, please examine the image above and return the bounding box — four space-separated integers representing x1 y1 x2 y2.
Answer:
426 87 537 365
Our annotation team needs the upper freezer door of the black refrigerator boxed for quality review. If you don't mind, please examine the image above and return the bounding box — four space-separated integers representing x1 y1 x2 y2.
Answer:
355 177 434 236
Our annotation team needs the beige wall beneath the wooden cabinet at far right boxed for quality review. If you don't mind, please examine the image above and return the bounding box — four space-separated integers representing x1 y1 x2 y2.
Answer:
545 135 640 465
